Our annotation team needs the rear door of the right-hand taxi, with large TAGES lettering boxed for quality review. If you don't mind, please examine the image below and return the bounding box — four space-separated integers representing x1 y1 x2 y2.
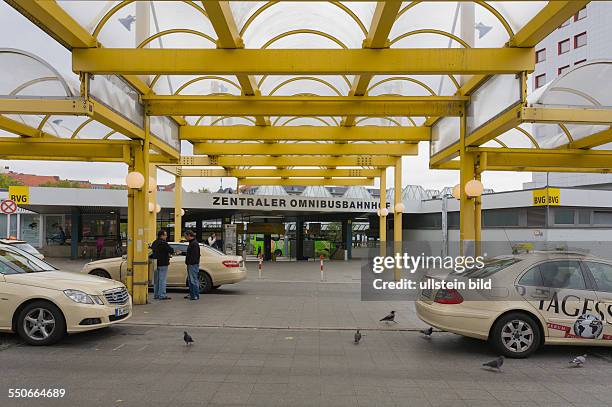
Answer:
519 259 597 340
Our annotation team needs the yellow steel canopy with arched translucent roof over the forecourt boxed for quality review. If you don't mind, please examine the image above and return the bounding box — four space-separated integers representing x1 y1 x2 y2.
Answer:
0 0 612 302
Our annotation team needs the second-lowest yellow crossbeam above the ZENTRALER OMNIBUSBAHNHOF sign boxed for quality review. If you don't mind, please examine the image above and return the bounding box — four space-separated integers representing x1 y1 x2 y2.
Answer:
173 167 380 178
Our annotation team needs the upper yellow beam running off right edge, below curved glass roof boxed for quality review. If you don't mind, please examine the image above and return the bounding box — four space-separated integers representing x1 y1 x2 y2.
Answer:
521 106 612 124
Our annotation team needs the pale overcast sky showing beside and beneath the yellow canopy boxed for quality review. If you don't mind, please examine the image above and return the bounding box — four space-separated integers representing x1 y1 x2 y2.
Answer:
0 2 531 191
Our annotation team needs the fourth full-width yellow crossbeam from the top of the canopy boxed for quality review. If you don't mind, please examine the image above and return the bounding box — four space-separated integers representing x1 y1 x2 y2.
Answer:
193 143 419 156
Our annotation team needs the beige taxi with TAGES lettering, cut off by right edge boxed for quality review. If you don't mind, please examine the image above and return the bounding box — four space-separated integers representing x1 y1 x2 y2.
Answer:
416 252 612 358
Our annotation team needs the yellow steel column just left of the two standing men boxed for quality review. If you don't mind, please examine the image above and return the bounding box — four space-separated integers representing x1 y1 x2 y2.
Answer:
132 116 150 304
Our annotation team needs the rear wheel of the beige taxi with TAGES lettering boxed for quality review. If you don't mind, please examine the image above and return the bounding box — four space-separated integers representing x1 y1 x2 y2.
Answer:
489 312 542 359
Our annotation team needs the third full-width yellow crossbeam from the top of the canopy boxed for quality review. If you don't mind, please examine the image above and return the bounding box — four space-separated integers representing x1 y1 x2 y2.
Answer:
180 126 431 142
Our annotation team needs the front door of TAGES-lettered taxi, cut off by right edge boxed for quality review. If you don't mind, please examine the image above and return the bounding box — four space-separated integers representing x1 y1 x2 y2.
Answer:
584 261 612 344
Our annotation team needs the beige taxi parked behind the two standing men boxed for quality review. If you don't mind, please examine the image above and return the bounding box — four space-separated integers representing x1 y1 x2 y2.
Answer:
81 242 247 294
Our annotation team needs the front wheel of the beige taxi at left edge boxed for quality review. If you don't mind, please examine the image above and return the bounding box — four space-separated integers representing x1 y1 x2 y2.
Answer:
17 301 66 346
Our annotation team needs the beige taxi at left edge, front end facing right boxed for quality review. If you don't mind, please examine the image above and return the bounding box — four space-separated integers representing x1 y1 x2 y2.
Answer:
0 244 132 345
